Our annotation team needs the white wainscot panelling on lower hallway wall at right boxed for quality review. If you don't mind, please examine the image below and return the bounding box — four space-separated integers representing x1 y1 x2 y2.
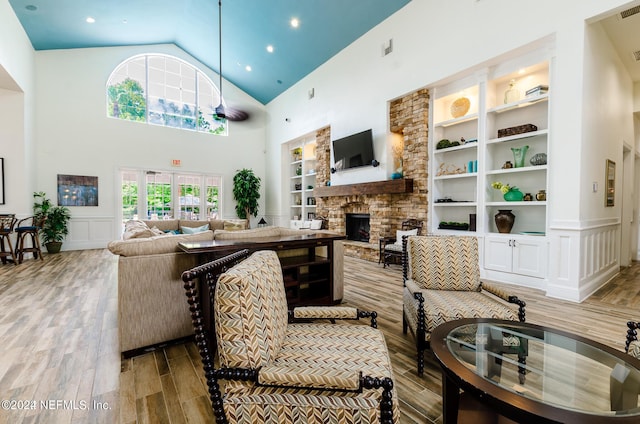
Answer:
547 219 620 302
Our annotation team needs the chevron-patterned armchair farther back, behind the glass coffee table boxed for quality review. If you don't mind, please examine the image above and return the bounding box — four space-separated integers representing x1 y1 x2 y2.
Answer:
402 236 525 375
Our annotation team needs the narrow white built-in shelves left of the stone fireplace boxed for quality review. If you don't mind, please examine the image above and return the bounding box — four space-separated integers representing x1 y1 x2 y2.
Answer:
287 138 317 228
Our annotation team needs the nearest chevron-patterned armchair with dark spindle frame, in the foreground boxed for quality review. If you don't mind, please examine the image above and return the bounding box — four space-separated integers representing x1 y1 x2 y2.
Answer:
182 250 399 424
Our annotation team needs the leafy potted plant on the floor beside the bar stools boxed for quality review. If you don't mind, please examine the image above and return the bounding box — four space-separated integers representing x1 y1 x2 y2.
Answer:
33 191 71 253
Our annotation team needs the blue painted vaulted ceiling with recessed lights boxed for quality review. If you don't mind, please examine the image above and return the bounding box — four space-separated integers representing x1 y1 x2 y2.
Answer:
9 0 410 104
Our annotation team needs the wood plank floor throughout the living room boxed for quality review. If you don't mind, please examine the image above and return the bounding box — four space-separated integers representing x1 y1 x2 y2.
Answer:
0 250 640 424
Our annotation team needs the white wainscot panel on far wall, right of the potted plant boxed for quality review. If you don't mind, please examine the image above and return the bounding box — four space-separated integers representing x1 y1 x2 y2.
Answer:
62 216 119 250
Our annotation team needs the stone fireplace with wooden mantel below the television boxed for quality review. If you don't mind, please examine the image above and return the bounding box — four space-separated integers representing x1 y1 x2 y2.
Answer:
314 89 429 262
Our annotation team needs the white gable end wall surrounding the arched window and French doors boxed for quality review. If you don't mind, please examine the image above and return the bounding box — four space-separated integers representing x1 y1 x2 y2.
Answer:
36 45 265 250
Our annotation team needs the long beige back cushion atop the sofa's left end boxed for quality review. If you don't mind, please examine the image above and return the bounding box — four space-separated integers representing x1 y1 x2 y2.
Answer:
107 230 213 256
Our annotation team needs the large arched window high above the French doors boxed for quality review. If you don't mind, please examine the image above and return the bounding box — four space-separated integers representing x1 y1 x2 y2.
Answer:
107 54 227 135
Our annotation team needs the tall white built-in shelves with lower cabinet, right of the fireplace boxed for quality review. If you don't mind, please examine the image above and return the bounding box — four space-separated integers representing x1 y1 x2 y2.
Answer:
429 55 553 286
